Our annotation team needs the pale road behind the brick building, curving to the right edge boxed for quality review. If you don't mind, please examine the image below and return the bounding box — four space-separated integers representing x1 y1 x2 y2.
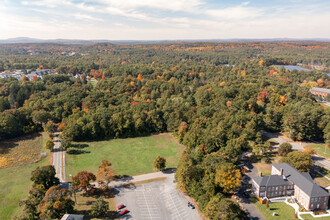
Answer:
262 131 330 169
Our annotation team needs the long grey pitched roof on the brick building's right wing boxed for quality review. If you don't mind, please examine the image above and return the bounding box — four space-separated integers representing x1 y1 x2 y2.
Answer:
273 163 329 197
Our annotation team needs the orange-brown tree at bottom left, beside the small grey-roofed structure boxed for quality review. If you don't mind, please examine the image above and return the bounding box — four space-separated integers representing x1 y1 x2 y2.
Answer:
38 186 74 219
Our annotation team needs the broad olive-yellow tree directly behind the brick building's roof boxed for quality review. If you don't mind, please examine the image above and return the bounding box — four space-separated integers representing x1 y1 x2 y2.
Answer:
281 151 314 172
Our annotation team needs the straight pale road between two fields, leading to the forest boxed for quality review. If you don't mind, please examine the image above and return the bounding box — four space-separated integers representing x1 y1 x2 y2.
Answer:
53 132 65 183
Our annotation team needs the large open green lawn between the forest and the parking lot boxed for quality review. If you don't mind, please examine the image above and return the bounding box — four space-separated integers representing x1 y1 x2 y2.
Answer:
66 134 184 179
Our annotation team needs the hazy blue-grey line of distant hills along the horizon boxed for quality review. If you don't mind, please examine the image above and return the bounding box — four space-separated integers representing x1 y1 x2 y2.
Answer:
0 37 330 45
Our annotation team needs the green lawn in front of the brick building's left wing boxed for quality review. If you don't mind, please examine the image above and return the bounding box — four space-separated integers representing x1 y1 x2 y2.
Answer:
250 197 295 220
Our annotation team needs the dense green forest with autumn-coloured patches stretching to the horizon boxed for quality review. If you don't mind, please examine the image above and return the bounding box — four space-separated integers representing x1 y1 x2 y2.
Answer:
0 42 330 219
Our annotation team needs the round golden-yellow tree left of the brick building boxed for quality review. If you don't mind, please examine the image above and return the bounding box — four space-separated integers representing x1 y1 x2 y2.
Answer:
215 163 242 193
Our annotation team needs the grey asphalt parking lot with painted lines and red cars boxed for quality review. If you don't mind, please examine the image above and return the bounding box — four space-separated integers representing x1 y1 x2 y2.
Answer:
114 174 200 220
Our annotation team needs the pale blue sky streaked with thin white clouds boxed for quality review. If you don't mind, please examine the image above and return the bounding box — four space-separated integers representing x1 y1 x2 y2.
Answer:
0 0 330 40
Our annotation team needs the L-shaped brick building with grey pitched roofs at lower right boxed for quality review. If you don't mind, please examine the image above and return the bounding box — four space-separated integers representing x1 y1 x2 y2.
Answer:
252 163 329 210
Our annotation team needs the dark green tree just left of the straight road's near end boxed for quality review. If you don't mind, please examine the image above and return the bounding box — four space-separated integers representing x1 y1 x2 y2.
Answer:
31 165 60 190
